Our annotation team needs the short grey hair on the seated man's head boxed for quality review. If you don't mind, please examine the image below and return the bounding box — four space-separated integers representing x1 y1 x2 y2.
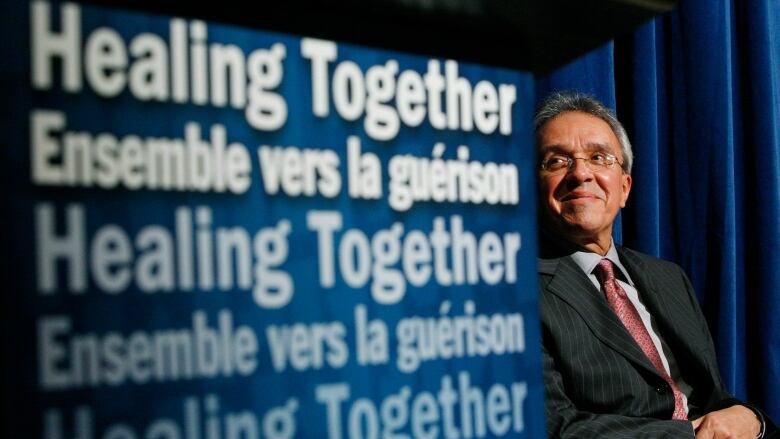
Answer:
534 91 634 175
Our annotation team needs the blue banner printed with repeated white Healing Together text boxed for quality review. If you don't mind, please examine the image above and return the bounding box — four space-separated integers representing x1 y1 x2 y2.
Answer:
1 1 544 439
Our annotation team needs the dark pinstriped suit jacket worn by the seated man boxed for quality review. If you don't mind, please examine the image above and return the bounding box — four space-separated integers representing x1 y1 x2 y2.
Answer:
539 248 772 439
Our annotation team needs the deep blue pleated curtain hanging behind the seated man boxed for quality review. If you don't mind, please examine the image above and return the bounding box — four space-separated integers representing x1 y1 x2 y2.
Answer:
536 0 780 421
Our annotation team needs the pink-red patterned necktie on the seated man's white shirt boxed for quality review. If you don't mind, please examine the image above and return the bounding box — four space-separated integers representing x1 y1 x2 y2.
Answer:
596 259 688 419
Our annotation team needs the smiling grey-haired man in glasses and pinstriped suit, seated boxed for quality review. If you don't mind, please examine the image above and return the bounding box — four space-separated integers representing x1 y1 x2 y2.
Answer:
534 93 775 439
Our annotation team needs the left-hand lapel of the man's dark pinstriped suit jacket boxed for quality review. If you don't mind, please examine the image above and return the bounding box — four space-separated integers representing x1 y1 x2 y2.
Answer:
539 256 660 376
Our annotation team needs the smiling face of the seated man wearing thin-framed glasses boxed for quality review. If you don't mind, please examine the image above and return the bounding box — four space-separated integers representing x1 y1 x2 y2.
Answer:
536 111 631 245
